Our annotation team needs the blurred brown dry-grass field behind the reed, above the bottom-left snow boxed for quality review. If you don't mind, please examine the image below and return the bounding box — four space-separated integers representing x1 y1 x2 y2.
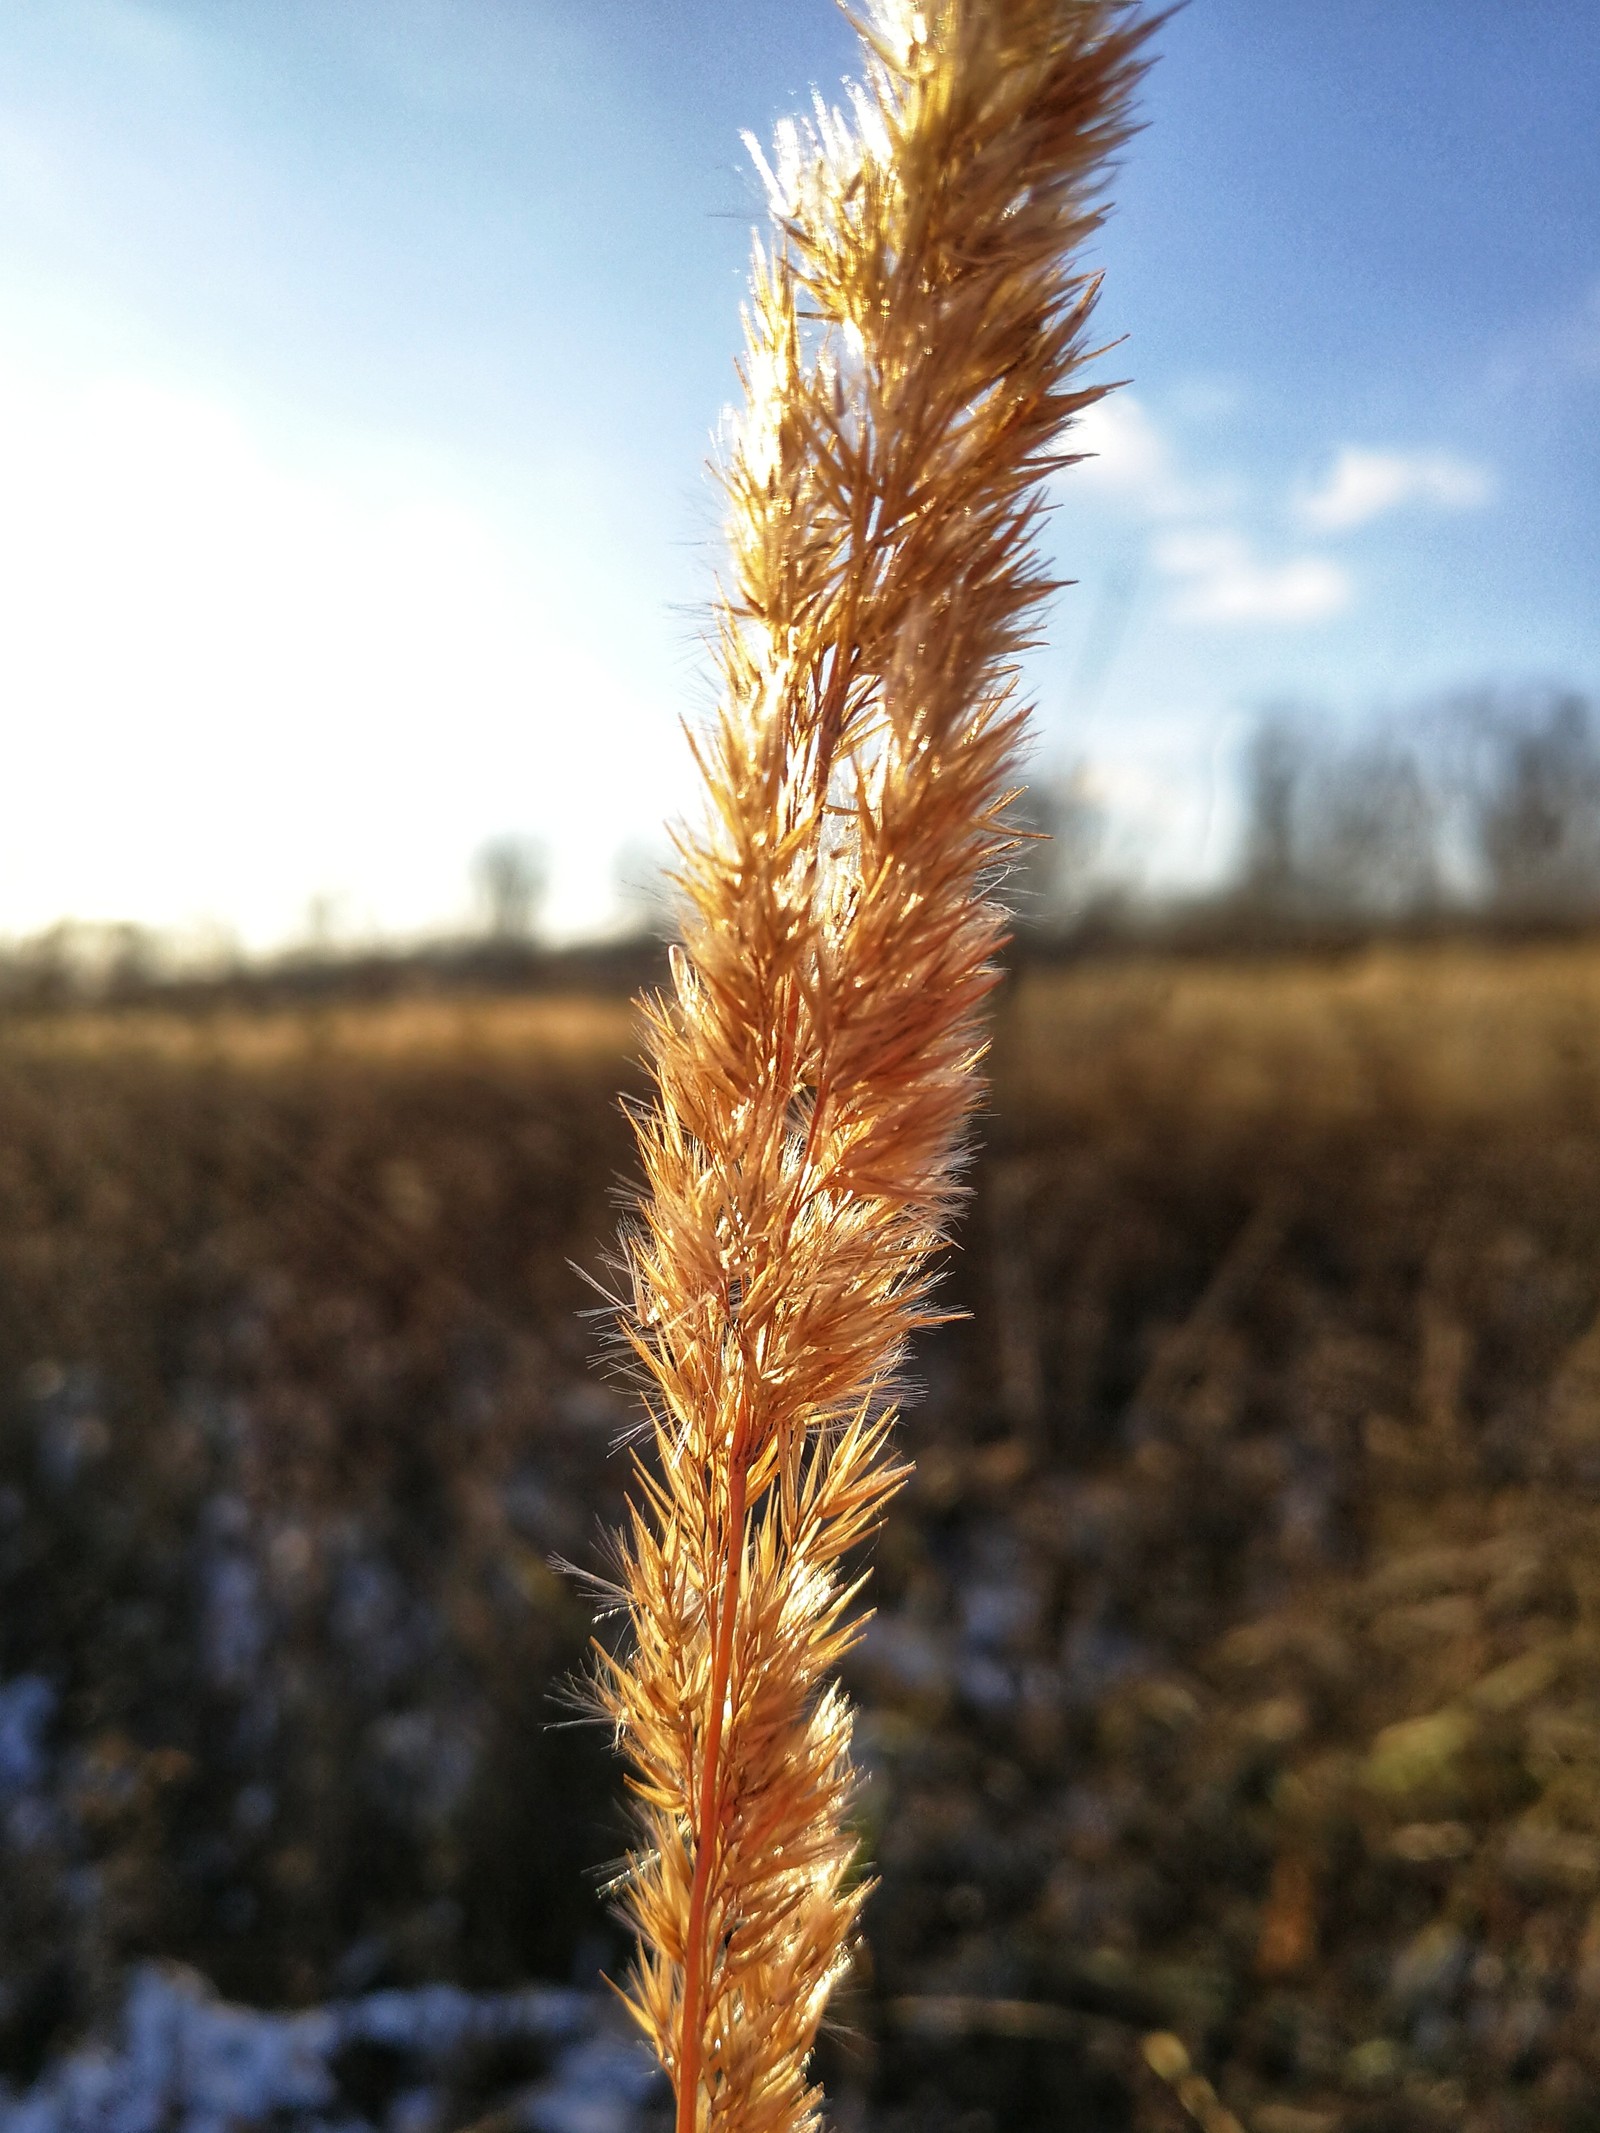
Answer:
0 943 1600 2133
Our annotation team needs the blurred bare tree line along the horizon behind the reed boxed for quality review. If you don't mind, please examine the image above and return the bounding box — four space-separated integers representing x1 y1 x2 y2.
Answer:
0 687 1600 1005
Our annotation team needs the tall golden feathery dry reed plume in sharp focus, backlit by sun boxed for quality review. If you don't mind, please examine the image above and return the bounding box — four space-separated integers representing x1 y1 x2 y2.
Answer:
599 0 1148 2133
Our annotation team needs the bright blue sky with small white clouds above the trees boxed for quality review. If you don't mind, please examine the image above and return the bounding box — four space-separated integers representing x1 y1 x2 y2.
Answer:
0 0 1600 945
